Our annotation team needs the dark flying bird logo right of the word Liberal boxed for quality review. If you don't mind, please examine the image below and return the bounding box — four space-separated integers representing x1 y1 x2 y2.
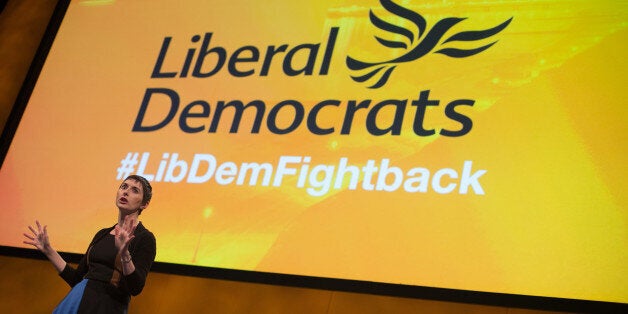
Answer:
346 0 513 89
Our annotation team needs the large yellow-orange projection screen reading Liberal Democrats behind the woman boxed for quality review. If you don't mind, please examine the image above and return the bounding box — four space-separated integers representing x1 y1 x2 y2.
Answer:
0 0 628 310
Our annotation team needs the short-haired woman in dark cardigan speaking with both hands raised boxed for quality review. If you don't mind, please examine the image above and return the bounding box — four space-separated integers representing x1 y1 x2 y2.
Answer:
24 175 156 313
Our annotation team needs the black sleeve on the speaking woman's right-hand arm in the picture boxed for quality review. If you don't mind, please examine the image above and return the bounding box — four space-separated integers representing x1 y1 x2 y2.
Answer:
124 232 157 296
